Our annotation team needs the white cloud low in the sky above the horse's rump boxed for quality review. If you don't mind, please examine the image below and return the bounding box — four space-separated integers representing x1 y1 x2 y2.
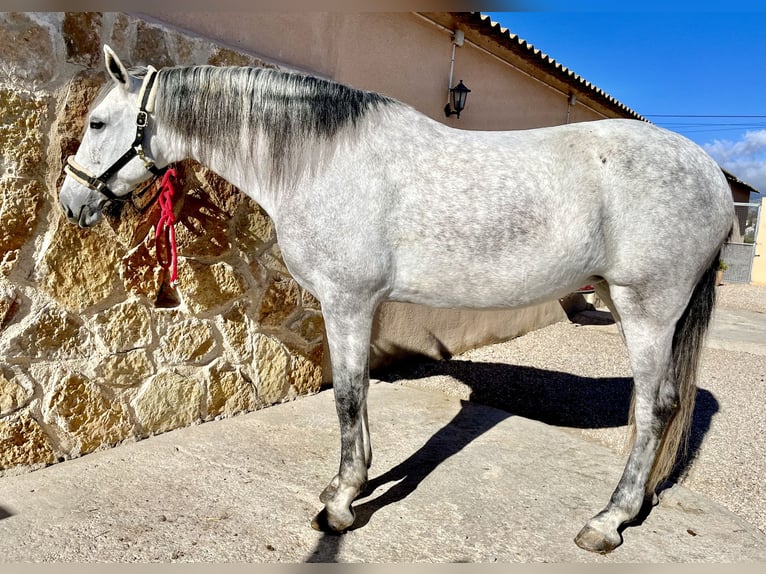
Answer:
702 130 766 195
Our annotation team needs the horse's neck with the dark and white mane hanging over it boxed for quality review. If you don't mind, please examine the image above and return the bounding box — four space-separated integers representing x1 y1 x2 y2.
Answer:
149 68 402 219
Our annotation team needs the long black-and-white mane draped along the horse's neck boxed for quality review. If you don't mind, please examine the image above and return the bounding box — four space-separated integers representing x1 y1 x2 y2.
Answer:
155 66 394 187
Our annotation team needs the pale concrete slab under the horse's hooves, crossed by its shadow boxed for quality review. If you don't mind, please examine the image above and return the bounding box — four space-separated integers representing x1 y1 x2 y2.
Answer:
0 306 766 563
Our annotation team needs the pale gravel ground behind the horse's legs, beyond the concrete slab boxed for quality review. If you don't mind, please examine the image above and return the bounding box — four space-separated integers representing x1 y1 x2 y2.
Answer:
376 284 766 533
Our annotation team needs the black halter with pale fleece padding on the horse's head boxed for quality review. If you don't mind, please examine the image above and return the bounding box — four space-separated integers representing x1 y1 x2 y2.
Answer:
64 66 167 201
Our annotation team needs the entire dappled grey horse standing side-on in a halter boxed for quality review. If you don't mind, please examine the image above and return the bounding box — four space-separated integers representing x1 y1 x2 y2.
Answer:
60 46 733 552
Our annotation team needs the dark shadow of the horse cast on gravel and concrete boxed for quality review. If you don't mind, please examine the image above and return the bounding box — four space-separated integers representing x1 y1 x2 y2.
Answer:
306 358 719 562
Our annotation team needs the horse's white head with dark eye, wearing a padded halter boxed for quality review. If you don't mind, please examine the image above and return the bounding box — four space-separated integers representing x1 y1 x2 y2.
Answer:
59 45 162 227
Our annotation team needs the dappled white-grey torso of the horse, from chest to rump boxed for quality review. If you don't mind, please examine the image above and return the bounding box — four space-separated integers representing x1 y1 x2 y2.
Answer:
278 116 733 308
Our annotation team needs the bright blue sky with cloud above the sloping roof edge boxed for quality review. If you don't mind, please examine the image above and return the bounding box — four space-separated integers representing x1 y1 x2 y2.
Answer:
483 9 766 195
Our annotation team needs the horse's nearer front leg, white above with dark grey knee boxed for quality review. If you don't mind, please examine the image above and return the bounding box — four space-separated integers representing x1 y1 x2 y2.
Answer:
312 304 374 532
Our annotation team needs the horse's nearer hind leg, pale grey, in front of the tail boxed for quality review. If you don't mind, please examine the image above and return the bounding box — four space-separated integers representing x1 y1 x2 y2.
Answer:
575 287 678 553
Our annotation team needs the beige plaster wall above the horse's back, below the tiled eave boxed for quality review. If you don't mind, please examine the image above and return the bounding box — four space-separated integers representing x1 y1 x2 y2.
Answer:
135 8 604 130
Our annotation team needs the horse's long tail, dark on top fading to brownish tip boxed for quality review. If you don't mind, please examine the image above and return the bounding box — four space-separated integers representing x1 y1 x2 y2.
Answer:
646 250 721 493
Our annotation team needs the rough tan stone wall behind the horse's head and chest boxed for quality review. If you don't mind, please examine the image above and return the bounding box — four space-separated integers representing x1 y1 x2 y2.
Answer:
0 13 323 472
